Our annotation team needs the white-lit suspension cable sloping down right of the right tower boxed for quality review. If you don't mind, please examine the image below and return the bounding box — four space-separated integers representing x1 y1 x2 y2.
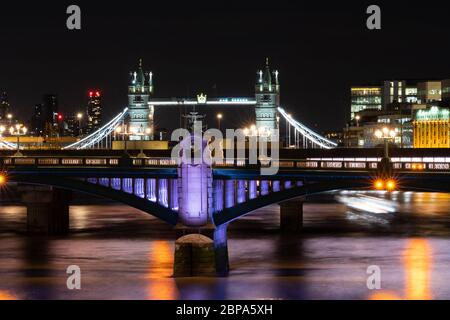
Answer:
278 107 337 149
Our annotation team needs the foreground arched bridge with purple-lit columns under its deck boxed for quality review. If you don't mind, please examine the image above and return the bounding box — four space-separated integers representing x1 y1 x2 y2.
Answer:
0 149 450 273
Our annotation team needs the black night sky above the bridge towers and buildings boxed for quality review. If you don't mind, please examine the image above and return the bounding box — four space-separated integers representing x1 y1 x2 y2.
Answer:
0 0 450 130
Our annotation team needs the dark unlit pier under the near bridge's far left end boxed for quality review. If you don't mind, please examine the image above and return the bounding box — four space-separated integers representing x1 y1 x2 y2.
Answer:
19 185 71 235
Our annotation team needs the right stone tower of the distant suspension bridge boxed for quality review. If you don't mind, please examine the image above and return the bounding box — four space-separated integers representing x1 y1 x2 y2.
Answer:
255 58 280 130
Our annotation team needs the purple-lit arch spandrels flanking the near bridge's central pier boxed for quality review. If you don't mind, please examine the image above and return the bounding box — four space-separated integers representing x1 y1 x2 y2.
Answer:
8 168 450 226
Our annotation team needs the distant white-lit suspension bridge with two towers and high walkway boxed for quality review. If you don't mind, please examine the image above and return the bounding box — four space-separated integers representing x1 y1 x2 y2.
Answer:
59 60 337 150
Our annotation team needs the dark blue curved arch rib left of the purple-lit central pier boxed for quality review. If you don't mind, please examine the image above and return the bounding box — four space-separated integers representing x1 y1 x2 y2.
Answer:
8 175 178 225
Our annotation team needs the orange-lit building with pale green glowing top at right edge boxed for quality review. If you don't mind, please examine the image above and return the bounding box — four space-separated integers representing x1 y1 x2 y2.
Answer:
413 106 450 148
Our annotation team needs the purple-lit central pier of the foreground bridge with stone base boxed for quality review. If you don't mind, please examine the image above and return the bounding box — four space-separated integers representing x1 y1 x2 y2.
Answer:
173 136 229 277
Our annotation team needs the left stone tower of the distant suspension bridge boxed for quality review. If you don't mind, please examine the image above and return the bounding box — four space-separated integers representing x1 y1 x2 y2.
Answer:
128 59 154 140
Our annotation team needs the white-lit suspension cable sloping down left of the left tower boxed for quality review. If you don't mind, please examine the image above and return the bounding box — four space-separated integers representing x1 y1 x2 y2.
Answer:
63 108 128 150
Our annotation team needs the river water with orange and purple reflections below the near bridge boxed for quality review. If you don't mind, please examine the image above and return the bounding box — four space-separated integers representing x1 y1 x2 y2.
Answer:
0 192 450 299
